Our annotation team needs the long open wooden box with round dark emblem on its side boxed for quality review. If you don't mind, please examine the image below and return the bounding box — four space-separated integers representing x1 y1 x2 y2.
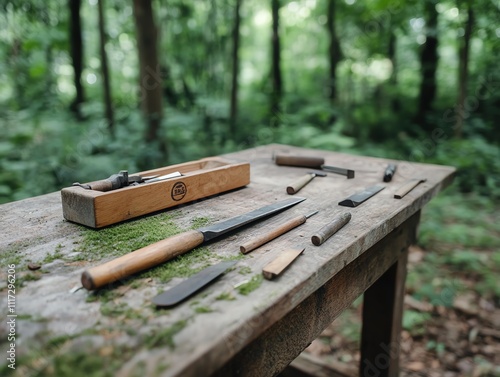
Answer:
61 158 250 228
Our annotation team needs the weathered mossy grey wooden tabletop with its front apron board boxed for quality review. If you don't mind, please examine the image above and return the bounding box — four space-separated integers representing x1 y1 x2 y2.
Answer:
0 145 454 376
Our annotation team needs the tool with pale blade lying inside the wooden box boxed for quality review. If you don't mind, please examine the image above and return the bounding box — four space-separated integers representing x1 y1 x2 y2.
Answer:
73 170 182 192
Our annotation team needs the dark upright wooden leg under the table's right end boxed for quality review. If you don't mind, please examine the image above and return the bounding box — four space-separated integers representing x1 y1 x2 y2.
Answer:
359 242 408 377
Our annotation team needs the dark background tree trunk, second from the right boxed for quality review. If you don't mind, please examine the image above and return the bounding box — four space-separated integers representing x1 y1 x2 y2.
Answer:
416 0 438 131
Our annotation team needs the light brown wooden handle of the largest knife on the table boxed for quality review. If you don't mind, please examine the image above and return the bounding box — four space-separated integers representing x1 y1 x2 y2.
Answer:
82 230 203 290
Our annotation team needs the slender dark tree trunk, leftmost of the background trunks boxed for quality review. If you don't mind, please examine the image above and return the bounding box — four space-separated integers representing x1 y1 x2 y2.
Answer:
68 0 84 118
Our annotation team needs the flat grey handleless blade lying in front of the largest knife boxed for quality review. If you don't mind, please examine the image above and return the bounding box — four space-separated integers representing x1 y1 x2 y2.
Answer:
153 261 237 307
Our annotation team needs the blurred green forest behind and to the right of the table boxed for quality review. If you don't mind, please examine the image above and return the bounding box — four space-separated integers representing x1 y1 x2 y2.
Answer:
0 0 500 373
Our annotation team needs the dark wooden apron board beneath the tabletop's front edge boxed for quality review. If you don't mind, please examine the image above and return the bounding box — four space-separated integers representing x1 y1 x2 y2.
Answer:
210 213 419 376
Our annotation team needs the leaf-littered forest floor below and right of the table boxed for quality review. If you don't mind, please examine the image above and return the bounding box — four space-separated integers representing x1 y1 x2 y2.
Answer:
298 194 500 377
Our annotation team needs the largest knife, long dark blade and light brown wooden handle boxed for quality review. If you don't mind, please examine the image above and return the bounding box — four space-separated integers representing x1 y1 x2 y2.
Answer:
82 197 305 290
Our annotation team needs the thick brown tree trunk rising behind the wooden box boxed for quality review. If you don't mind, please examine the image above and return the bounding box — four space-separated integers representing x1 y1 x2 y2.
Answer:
134 0 166 154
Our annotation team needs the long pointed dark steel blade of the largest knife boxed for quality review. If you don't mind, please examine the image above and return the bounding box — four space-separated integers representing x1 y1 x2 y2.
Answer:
198 197 306 241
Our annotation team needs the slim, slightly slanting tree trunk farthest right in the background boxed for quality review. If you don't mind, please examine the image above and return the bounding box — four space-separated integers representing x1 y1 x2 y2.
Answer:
455 4 474 139
